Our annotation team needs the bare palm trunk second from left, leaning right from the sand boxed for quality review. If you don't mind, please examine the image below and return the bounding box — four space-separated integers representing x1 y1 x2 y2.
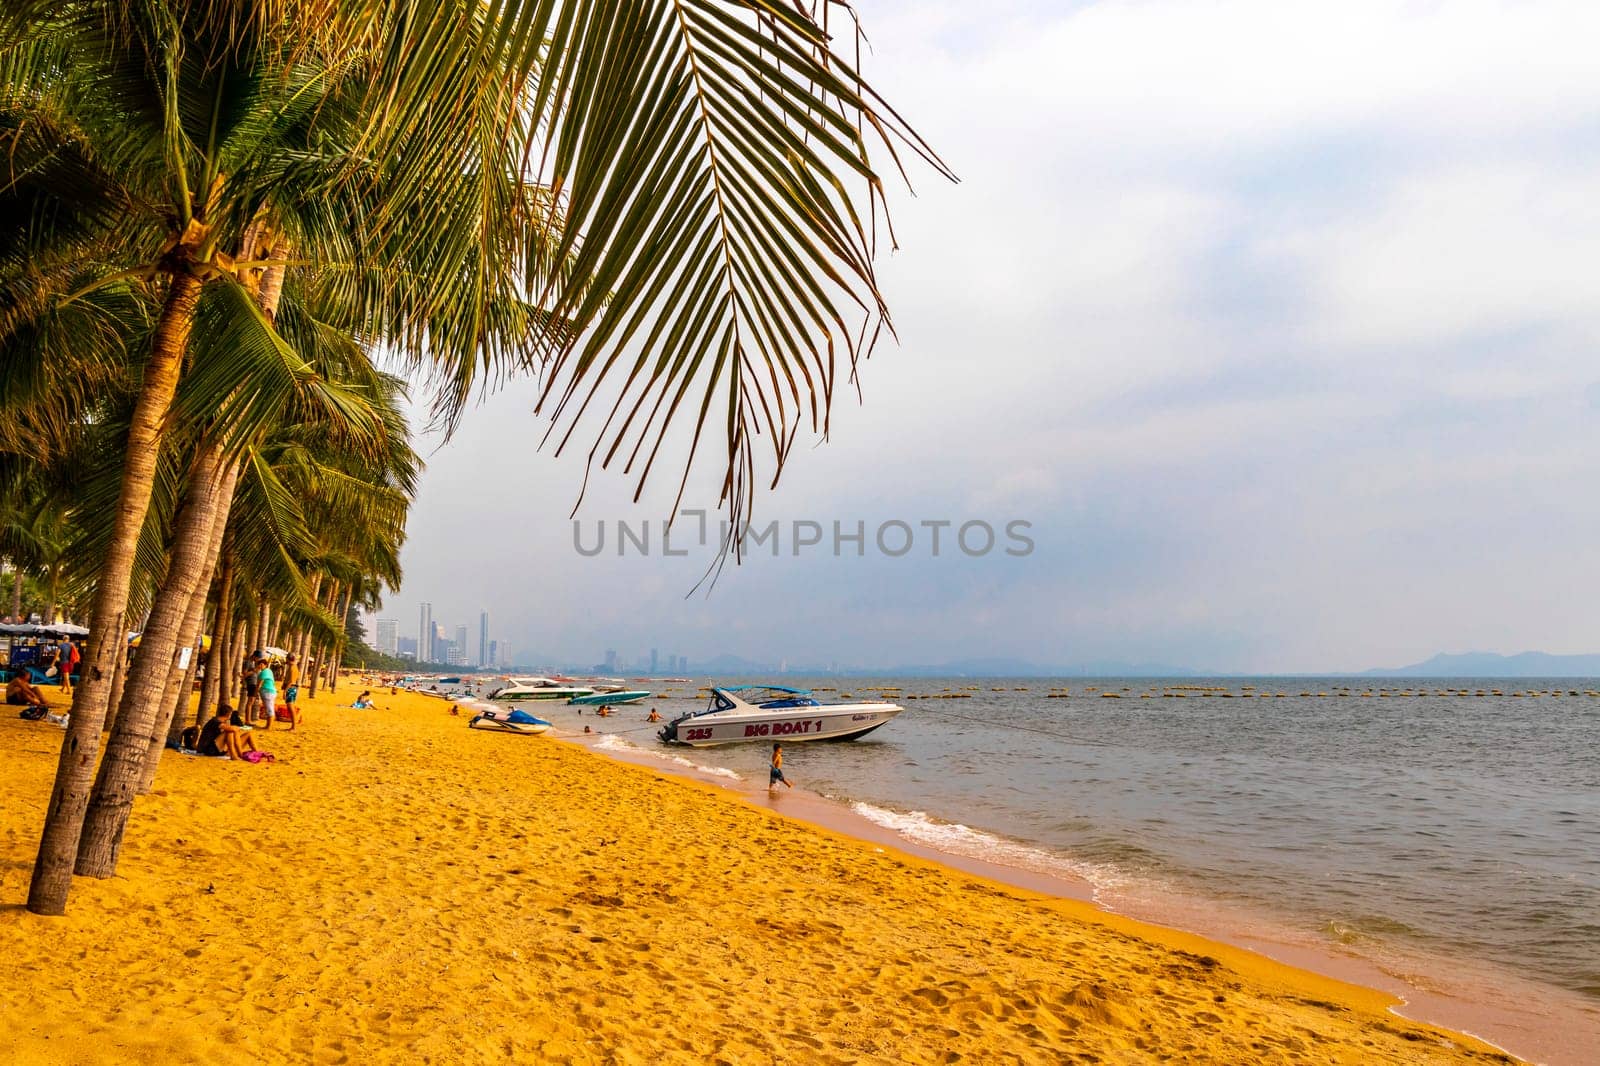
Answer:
77 442 232 877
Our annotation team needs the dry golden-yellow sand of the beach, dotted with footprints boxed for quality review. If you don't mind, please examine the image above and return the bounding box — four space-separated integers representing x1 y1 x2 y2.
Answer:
0 680 1501 1063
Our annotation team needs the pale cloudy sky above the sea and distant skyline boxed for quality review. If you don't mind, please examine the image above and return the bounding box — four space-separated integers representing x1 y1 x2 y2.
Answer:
379 0 1600 672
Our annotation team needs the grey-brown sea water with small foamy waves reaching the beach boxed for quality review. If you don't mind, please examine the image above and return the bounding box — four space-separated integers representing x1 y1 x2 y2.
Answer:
541 677 1600 1005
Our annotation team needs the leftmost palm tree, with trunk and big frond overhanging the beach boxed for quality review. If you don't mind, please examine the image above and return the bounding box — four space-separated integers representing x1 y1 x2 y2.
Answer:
0 0 928 914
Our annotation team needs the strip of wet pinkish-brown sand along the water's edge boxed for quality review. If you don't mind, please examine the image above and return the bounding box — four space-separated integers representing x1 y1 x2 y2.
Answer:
552 725 1600 1064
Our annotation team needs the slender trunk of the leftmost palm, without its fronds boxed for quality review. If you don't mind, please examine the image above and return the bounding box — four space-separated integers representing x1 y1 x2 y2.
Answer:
27 271 205 914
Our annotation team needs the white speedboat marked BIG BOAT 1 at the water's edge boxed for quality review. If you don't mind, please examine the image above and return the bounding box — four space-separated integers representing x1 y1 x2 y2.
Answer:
658 685 906 747
